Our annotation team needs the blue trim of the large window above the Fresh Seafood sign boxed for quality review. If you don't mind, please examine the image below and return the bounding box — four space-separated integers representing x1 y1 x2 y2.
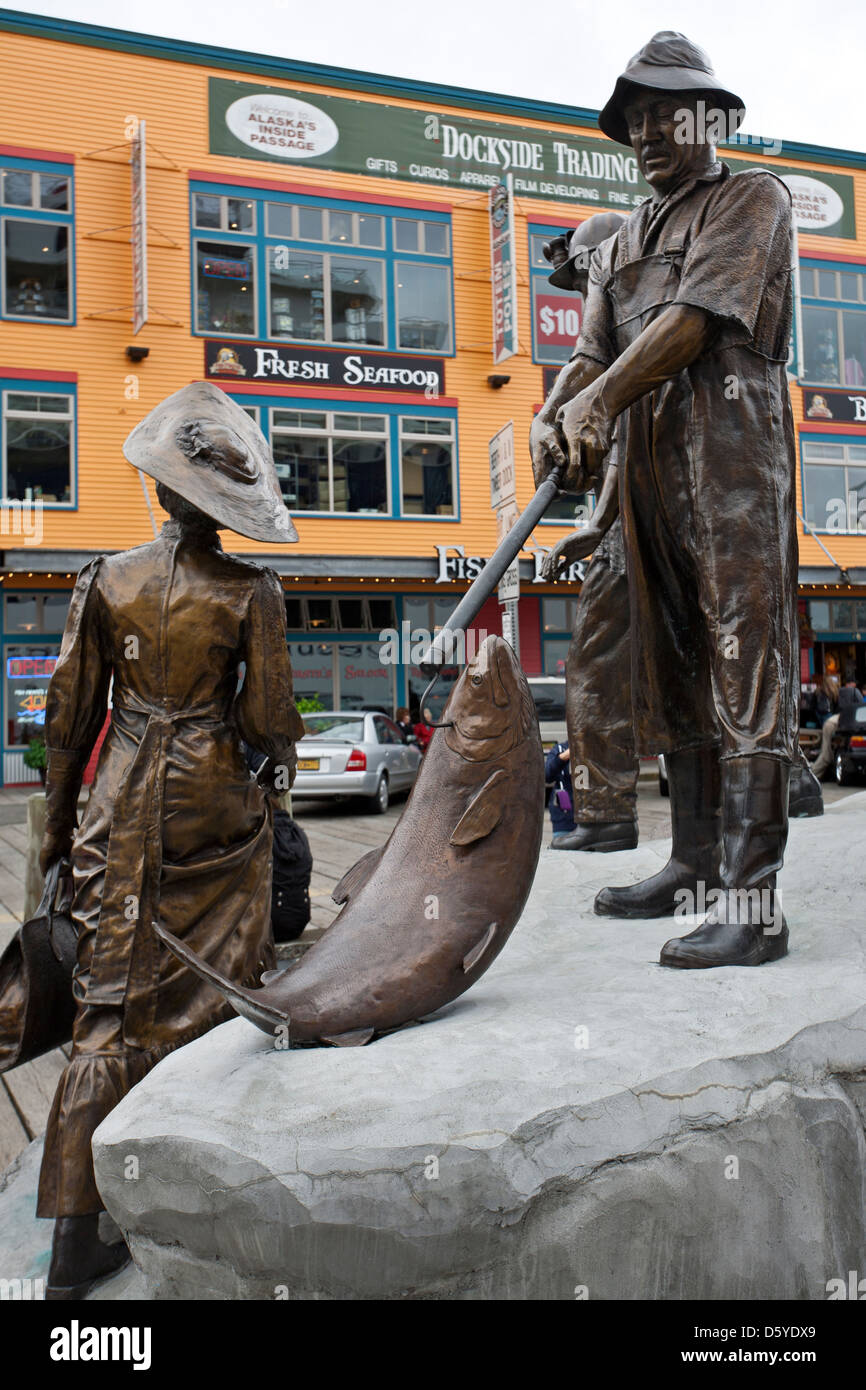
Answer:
189 179 456 357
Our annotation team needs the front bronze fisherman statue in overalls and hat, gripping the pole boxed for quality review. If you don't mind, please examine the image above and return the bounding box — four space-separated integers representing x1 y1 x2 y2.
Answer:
534 32 798 969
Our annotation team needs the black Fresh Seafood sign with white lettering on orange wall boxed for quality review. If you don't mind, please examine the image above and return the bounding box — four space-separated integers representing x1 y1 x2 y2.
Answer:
204 338 445 400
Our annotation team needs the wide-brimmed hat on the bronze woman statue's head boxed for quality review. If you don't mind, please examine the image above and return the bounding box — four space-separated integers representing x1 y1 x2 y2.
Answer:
124 381 297 545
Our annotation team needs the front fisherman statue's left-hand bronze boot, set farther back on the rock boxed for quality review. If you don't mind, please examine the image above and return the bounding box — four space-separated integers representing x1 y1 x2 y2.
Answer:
595 744 721 917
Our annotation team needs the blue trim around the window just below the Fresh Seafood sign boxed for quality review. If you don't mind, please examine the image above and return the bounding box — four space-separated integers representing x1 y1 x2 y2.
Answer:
229 392 460 525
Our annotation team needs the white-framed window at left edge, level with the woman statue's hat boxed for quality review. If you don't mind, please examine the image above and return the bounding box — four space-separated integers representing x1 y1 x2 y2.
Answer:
3 384 75 506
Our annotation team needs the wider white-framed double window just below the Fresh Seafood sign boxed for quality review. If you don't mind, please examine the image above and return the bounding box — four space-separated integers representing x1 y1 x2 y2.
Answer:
271 410 389 516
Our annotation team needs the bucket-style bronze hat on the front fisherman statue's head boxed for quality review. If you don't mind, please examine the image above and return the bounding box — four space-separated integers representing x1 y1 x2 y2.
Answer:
598 29 745 146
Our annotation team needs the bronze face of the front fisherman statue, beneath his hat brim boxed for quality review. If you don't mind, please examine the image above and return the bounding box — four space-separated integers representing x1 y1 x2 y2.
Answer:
626 88 714 197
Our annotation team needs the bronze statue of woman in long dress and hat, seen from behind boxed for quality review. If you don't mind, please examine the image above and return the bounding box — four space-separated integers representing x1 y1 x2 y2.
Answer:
38 384 303 1298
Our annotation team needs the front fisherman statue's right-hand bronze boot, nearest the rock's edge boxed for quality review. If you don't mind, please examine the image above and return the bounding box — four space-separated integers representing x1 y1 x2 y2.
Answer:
660 753 791 970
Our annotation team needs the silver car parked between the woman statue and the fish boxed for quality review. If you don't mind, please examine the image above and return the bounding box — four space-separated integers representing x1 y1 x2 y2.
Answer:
292 709 421 816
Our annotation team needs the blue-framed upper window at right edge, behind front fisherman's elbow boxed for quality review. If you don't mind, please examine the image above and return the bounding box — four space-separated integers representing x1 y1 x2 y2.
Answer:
799 265 866 386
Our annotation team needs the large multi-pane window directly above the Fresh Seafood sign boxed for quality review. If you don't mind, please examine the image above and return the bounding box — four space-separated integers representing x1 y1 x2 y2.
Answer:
192 188 453 354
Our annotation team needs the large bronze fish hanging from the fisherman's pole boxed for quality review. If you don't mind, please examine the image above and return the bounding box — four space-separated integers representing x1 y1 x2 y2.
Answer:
154 637 544 1047
